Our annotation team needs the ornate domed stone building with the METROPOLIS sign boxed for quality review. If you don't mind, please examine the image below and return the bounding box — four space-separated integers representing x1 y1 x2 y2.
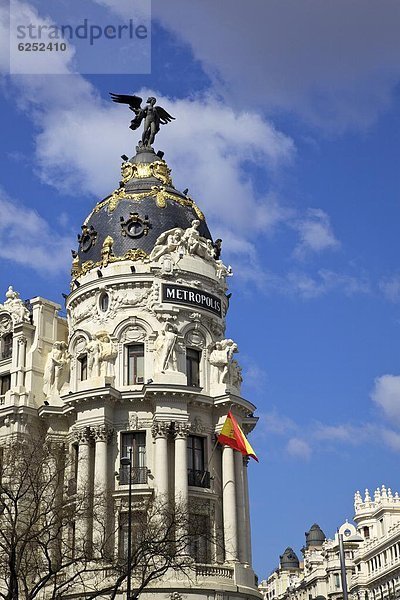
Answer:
0 143 259 600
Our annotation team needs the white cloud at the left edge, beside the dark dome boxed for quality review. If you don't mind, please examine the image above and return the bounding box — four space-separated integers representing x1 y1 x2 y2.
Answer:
0 189 74 274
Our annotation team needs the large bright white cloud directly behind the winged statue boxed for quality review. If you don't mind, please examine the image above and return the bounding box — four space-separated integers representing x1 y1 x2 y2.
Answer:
2 0 378 299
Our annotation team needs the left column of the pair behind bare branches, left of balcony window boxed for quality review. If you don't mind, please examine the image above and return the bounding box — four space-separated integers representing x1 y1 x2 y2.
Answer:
74 427 93 547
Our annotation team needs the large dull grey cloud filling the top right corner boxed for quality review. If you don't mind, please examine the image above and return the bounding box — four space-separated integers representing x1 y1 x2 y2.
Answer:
153 0 400 134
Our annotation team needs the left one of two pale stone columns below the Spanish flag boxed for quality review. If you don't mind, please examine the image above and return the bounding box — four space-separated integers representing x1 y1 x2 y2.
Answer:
222 446 238 561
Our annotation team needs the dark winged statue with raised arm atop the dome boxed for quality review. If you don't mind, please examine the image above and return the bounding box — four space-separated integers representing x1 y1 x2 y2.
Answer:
110 92 175 146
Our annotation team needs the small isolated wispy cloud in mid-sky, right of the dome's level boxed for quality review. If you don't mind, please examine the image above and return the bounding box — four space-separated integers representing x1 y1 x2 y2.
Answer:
293 208 340 259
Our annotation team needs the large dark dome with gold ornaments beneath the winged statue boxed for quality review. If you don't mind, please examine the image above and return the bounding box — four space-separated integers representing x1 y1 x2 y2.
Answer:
78 148 212 268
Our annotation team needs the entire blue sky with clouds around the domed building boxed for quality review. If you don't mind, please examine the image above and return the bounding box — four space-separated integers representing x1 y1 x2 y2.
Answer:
0 0 400 578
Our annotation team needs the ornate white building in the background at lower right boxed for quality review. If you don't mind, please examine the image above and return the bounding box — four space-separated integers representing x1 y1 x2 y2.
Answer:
260 485 400 600
